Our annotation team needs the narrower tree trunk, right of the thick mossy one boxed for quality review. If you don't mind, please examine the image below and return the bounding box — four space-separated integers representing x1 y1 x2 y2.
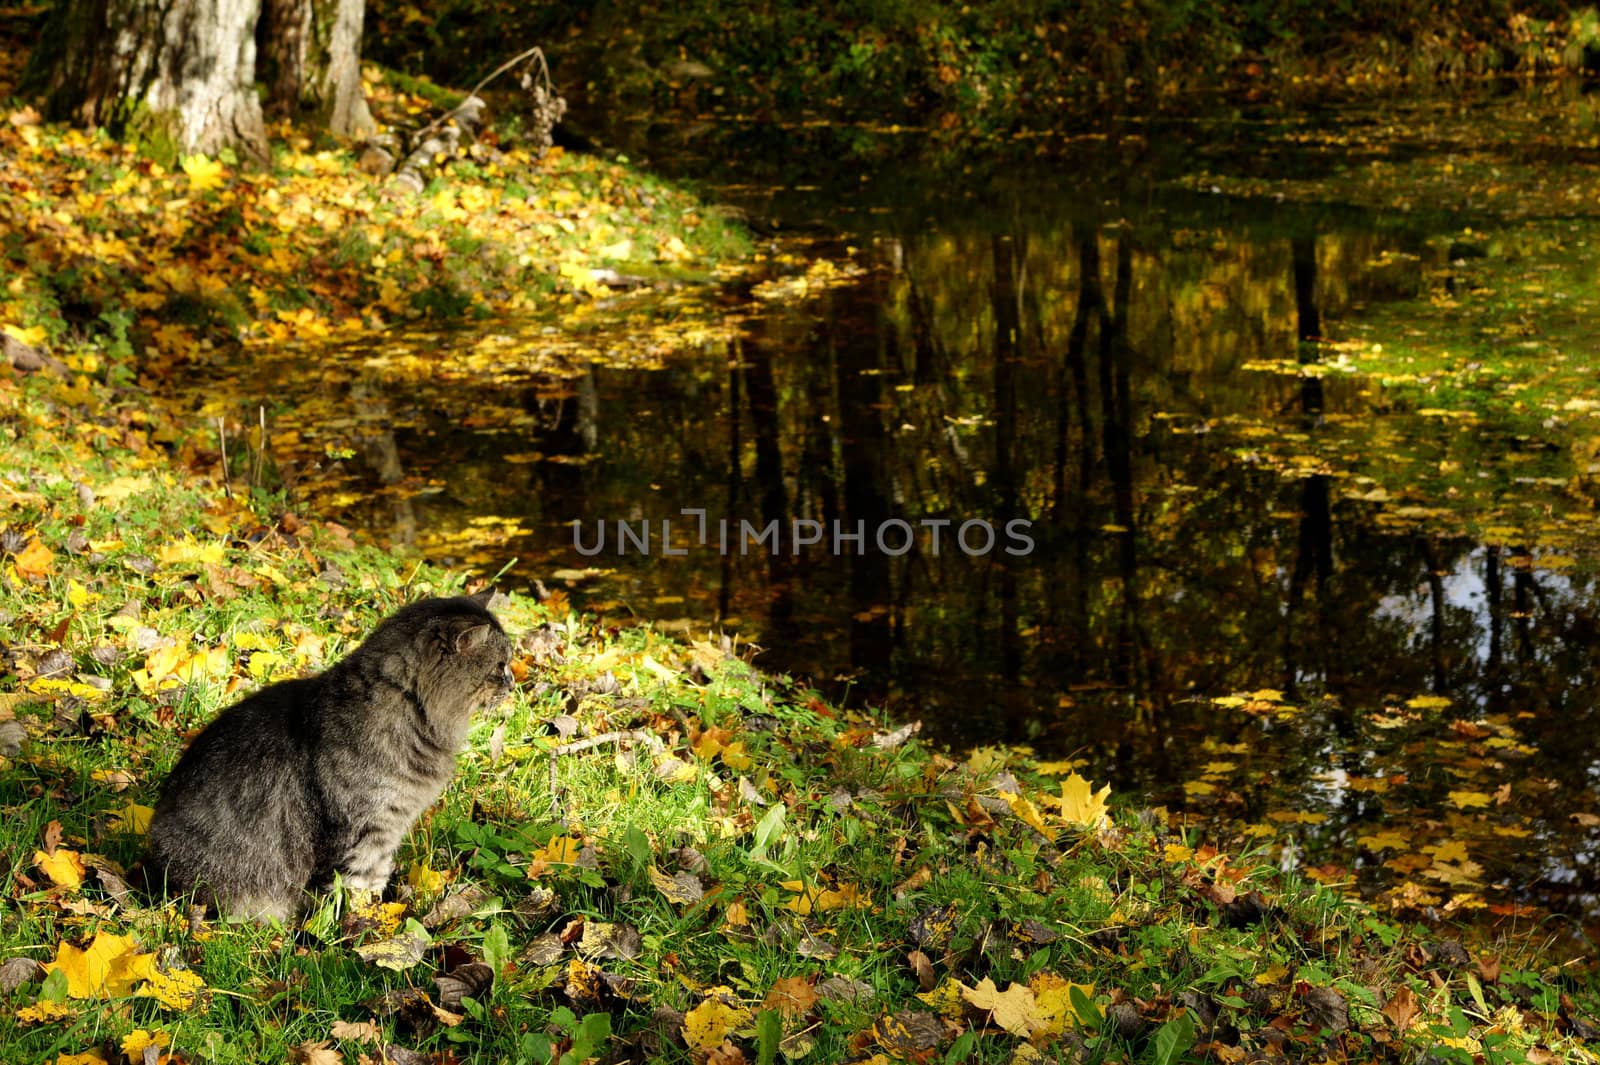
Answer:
259 0 376 136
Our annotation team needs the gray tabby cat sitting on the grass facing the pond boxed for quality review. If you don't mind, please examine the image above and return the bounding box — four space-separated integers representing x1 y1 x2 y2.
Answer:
147 593 512 921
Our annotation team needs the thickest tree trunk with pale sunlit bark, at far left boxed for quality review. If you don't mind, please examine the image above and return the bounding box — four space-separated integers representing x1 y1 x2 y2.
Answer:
29 0 267 160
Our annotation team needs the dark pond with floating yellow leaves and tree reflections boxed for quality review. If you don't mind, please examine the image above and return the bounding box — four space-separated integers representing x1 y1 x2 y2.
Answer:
190 88 1600 929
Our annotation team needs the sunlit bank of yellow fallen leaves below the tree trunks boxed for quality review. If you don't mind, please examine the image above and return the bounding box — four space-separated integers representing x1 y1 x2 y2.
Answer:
0 59 749 381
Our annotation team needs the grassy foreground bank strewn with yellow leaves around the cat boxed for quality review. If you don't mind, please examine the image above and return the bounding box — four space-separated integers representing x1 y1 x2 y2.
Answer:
9 351 1600 1065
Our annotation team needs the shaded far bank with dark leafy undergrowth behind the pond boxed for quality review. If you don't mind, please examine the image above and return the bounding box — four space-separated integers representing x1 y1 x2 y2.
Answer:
368 0 1600 131
